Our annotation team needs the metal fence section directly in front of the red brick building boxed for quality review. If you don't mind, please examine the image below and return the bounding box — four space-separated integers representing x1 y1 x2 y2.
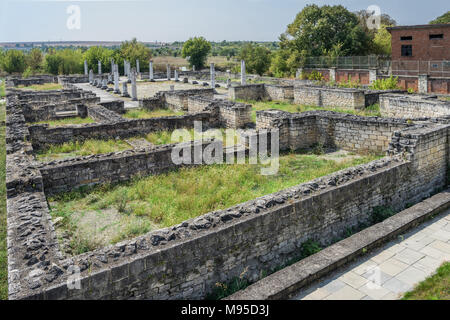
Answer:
391 60 450 78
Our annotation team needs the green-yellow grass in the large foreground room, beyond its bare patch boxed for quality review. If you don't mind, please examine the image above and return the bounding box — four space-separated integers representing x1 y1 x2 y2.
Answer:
49 154 378 252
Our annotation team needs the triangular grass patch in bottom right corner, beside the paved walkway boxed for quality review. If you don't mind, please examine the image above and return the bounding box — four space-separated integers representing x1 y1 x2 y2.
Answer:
403 262 450 300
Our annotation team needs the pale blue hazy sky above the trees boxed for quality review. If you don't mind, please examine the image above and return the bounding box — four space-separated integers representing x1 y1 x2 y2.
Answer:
0 0 450 42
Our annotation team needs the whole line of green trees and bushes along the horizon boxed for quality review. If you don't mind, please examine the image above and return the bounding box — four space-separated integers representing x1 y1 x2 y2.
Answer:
0 4 450 77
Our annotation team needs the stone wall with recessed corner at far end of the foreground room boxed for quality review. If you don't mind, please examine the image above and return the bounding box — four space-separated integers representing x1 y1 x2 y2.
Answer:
256 110 412 152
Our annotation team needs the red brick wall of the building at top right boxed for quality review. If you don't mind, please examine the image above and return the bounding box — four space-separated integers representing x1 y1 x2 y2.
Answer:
391 24 450 60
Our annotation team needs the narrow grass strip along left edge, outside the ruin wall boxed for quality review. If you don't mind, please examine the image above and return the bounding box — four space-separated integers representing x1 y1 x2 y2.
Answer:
0 103 8 300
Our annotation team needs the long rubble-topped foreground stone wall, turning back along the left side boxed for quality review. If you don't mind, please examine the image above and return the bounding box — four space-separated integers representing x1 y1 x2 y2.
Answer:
7 85 449 299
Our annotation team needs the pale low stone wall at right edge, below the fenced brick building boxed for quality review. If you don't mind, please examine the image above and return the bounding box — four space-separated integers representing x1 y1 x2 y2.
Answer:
380 94 450 119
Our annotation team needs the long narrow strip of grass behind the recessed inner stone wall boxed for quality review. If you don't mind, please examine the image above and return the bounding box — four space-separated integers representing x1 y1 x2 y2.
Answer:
239 100 381 121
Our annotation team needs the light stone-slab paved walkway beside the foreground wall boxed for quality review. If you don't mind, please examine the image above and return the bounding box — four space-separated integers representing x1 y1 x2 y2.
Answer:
294 210 450 300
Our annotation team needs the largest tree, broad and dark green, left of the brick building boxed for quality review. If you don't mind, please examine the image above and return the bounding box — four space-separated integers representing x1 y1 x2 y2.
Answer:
272 5 370 74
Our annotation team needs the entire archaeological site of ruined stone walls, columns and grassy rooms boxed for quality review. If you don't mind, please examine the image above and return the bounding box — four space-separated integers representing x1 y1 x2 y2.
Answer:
2 61 450 300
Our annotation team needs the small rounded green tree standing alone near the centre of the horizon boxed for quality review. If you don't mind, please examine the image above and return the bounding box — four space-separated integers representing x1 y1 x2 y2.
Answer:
239 43 271 76
